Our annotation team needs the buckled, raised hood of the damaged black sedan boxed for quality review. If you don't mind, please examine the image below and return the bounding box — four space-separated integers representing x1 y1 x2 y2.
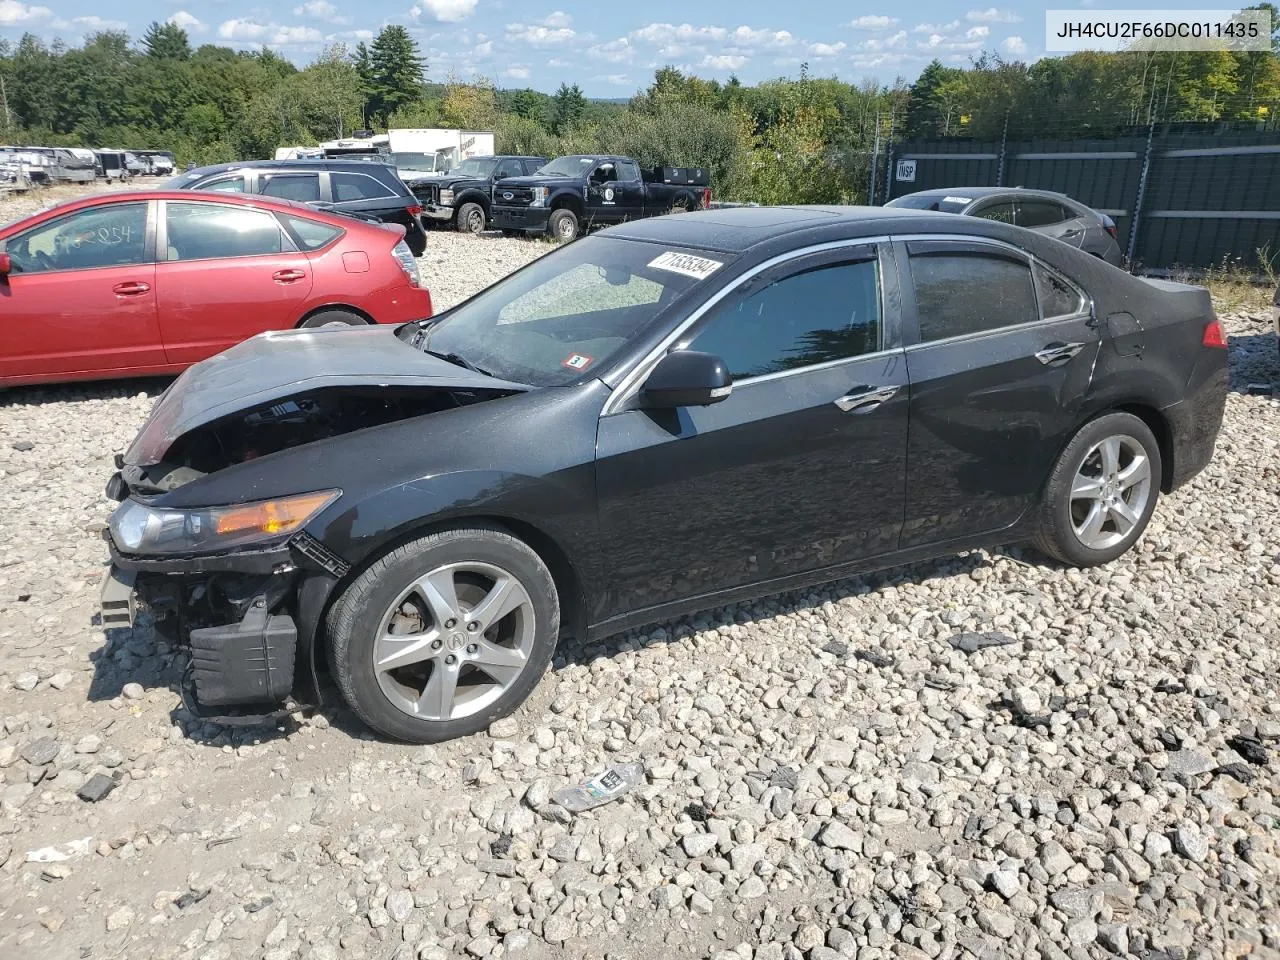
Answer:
124 326 529 465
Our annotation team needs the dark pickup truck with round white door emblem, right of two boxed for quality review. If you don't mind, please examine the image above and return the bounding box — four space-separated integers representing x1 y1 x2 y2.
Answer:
493 155 712 242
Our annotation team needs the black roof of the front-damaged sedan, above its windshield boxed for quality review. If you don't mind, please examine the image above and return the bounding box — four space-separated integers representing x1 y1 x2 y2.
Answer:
608 206 967 253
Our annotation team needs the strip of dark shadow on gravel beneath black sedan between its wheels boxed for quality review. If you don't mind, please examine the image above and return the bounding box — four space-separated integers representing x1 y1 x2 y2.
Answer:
554 547 1013 669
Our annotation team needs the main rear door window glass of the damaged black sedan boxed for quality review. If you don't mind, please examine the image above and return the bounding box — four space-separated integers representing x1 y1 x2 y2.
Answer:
909 244 1039 343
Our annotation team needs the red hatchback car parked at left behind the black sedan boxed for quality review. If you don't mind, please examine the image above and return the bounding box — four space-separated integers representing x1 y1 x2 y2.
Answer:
0 191 431 387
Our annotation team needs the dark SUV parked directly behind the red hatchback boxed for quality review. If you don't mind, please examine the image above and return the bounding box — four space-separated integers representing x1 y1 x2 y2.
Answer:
165 160 426 257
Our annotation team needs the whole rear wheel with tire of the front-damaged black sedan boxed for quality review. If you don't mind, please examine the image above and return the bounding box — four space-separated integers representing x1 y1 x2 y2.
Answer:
1036 413 1164 567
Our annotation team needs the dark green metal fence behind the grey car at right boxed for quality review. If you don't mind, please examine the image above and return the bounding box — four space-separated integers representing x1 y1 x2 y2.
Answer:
877 131 1280 271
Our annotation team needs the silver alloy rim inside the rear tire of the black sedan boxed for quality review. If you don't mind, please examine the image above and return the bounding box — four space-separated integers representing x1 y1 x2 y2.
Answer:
1070 435 1152 550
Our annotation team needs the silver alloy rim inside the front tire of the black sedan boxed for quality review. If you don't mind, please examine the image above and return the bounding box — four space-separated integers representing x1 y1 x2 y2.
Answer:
374 562 536 721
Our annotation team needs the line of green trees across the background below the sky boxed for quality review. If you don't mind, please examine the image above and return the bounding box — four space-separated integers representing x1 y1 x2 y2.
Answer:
0 15 1280 204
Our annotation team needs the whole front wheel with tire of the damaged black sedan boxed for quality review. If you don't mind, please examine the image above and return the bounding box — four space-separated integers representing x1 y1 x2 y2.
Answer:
326 527 559 744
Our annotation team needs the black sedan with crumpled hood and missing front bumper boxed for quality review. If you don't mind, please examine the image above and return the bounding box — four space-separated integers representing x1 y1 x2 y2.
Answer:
102 207 1226 741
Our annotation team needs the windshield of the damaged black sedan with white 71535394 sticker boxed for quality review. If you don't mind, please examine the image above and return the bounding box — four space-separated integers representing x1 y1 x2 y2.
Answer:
399 237 730 387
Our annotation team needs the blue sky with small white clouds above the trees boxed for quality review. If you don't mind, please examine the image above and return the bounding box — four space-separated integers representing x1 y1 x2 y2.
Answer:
0 0 1172 97
